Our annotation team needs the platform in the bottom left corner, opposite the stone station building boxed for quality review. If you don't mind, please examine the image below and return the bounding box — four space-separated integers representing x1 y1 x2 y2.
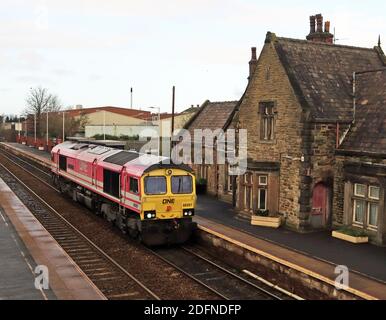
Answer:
0 179 105 300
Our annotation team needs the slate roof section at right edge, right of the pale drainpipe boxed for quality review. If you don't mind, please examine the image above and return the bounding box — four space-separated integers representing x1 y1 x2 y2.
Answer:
339 68 386 158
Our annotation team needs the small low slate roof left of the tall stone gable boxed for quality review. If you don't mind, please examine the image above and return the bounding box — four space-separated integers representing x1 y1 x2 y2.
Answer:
184 100 238 137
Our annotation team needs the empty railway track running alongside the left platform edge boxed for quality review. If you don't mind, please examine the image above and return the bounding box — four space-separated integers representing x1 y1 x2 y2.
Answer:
0 155 160 300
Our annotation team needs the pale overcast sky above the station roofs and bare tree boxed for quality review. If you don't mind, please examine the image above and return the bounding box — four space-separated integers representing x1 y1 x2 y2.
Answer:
0 0 386 114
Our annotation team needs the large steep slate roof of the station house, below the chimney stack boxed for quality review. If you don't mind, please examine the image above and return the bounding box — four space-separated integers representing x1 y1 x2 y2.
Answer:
272 33 386 121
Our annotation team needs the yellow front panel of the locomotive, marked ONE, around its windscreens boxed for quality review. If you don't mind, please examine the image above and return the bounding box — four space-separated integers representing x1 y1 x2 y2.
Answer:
141 169 196 219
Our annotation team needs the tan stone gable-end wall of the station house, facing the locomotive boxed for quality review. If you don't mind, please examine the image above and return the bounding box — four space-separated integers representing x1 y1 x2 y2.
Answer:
234 43 304 228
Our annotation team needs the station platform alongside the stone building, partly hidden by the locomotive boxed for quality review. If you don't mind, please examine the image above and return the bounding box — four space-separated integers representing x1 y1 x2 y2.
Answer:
0 143 386 300
